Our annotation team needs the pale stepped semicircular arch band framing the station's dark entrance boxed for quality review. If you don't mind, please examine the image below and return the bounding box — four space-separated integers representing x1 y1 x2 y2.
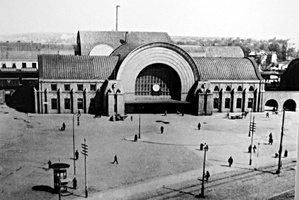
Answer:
117 42 199 100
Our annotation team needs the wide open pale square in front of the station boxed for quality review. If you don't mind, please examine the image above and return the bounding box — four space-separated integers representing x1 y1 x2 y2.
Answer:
0 105 298 200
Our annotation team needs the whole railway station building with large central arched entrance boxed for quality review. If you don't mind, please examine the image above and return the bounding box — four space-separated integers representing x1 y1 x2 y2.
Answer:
34 31 265 115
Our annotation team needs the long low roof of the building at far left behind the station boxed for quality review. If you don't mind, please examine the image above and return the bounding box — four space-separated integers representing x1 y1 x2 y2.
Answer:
0 42 75 60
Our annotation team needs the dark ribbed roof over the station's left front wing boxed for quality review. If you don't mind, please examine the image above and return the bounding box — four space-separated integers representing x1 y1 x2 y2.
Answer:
38 55 118 80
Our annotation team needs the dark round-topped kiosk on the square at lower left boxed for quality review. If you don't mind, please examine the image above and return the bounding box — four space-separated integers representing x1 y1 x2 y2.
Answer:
51 163 71 192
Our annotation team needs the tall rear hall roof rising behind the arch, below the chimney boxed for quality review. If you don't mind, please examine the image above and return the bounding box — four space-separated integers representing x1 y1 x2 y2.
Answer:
77 31 171 55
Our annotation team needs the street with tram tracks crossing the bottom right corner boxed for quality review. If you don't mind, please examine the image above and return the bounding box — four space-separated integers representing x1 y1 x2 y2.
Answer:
130 159 296 200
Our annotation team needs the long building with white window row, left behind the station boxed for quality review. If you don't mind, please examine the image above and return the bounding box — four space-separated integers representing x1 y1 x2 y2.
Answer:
0 42 75 100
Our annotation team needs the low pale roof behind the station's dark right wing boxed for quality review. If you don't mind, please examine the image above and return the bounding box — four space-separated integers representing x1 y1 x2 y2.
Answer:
179 45 244 58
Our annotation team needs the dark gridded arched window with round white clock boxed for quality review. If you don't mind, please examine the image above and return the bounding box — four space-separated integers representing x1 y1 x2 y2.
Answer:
135 63 181 100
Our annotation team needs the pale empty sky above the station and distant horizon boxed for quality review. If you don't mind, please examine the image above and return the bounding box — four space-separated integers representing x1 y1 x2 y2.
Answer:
0 0 299 39
